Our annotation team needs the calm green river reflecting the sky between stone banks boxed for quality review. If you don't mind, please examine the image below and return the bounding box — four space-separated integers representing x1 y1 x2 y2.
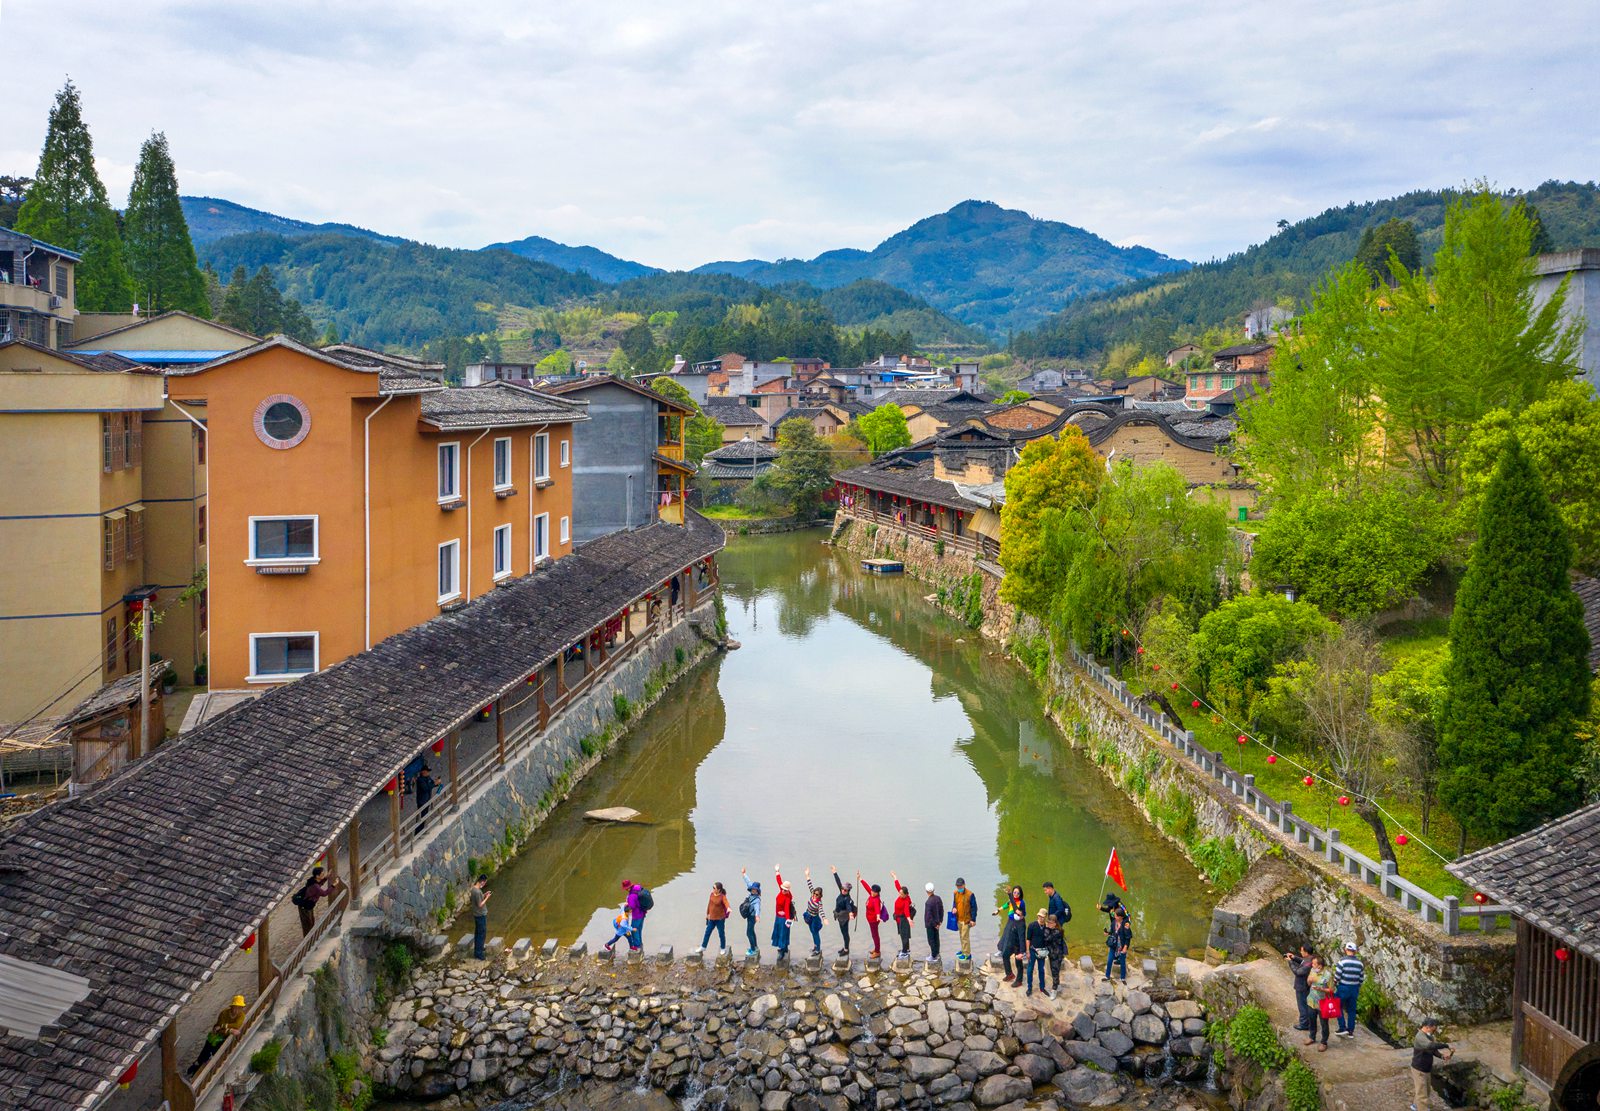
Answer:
490 531 1214 961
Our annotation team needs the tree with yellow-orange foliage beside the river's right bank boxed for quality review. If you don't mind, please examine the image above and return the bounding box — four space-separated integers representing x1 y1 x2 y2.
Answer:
992 424 1104 618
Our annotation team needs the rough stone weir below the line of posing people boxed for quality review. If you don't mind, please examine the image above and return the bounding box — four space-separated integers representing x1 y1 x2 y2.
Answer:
370 943 1214 1111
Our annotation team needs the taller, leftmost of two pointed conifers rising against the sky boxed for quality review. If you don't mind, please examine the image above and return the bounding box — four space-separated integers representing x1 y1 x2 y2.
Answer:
16 82 133 312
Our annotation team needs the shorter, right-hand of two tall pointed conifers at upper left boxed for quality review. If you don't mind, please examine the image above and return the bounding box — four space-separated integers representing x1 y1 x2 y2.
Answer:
122 131 211 317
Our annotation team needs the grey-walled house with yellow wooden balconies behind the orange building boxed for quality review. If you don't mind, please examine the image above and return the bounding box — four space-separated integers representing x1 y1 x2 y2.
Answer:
547 375 694 544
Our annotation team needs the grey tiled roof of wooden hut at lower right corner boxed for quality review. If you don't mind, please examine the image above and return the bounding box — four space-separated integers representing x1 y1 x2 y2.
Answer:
1445 802 1600 961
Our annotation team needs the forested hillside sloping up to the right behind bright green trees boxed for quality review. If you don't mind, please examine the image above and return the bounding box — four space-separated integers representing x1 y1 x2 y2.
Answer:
1011 181 1600 363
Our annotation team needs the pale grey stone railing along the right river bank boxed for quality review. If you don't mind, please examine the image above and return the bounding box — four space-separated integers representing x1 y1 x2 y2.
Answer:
1072 647 1510 937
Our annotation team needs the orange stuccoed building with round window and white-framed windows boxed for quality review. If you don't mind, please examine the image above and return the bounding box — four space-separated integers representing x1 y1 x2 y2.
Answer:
168 336 587 690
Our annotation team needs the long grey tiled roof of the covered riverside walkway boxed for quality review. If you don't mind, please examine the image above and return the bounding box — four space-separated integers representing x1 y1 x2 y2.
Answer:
0 514 723 1111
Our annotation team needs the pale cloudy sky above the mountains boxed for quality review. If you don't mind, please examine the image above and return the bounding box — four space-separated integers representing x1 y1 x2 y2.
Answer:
0 0 1600 269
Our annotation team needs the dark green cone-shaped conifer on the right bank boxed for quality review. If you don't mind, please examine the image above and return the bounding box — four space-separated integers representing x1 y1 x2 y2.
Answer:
1438 439 1590 839
